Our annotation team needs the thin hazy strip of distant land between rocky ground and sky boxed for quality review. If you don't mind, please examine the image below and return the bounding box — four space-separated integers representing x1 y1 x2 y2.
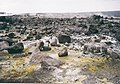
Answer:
0 11 120 18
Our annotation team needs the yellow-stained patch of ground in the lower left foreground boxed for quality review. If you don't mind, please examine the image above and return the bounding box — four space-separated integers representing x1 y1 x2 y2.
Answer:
2 57 36 78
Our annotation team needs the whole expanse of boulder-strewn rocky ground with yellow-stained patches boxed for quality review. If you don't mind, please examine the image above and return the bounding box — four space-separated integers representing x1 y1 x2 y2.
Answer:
0 15 120 84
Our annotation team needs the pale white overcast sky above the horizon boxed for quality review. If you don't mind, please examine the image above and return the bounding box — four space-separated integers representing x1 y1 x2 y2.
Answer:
0 0 120 13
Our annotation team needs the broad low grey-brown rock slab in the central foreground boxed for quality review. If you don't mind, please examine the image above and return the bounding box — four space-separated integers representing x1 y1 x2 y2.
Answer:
29 52 62 68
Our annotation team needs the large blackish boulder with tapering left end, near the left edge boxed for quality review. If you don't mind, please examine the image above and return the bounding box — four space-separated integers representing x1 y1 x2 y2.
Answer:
2 43 24 54
